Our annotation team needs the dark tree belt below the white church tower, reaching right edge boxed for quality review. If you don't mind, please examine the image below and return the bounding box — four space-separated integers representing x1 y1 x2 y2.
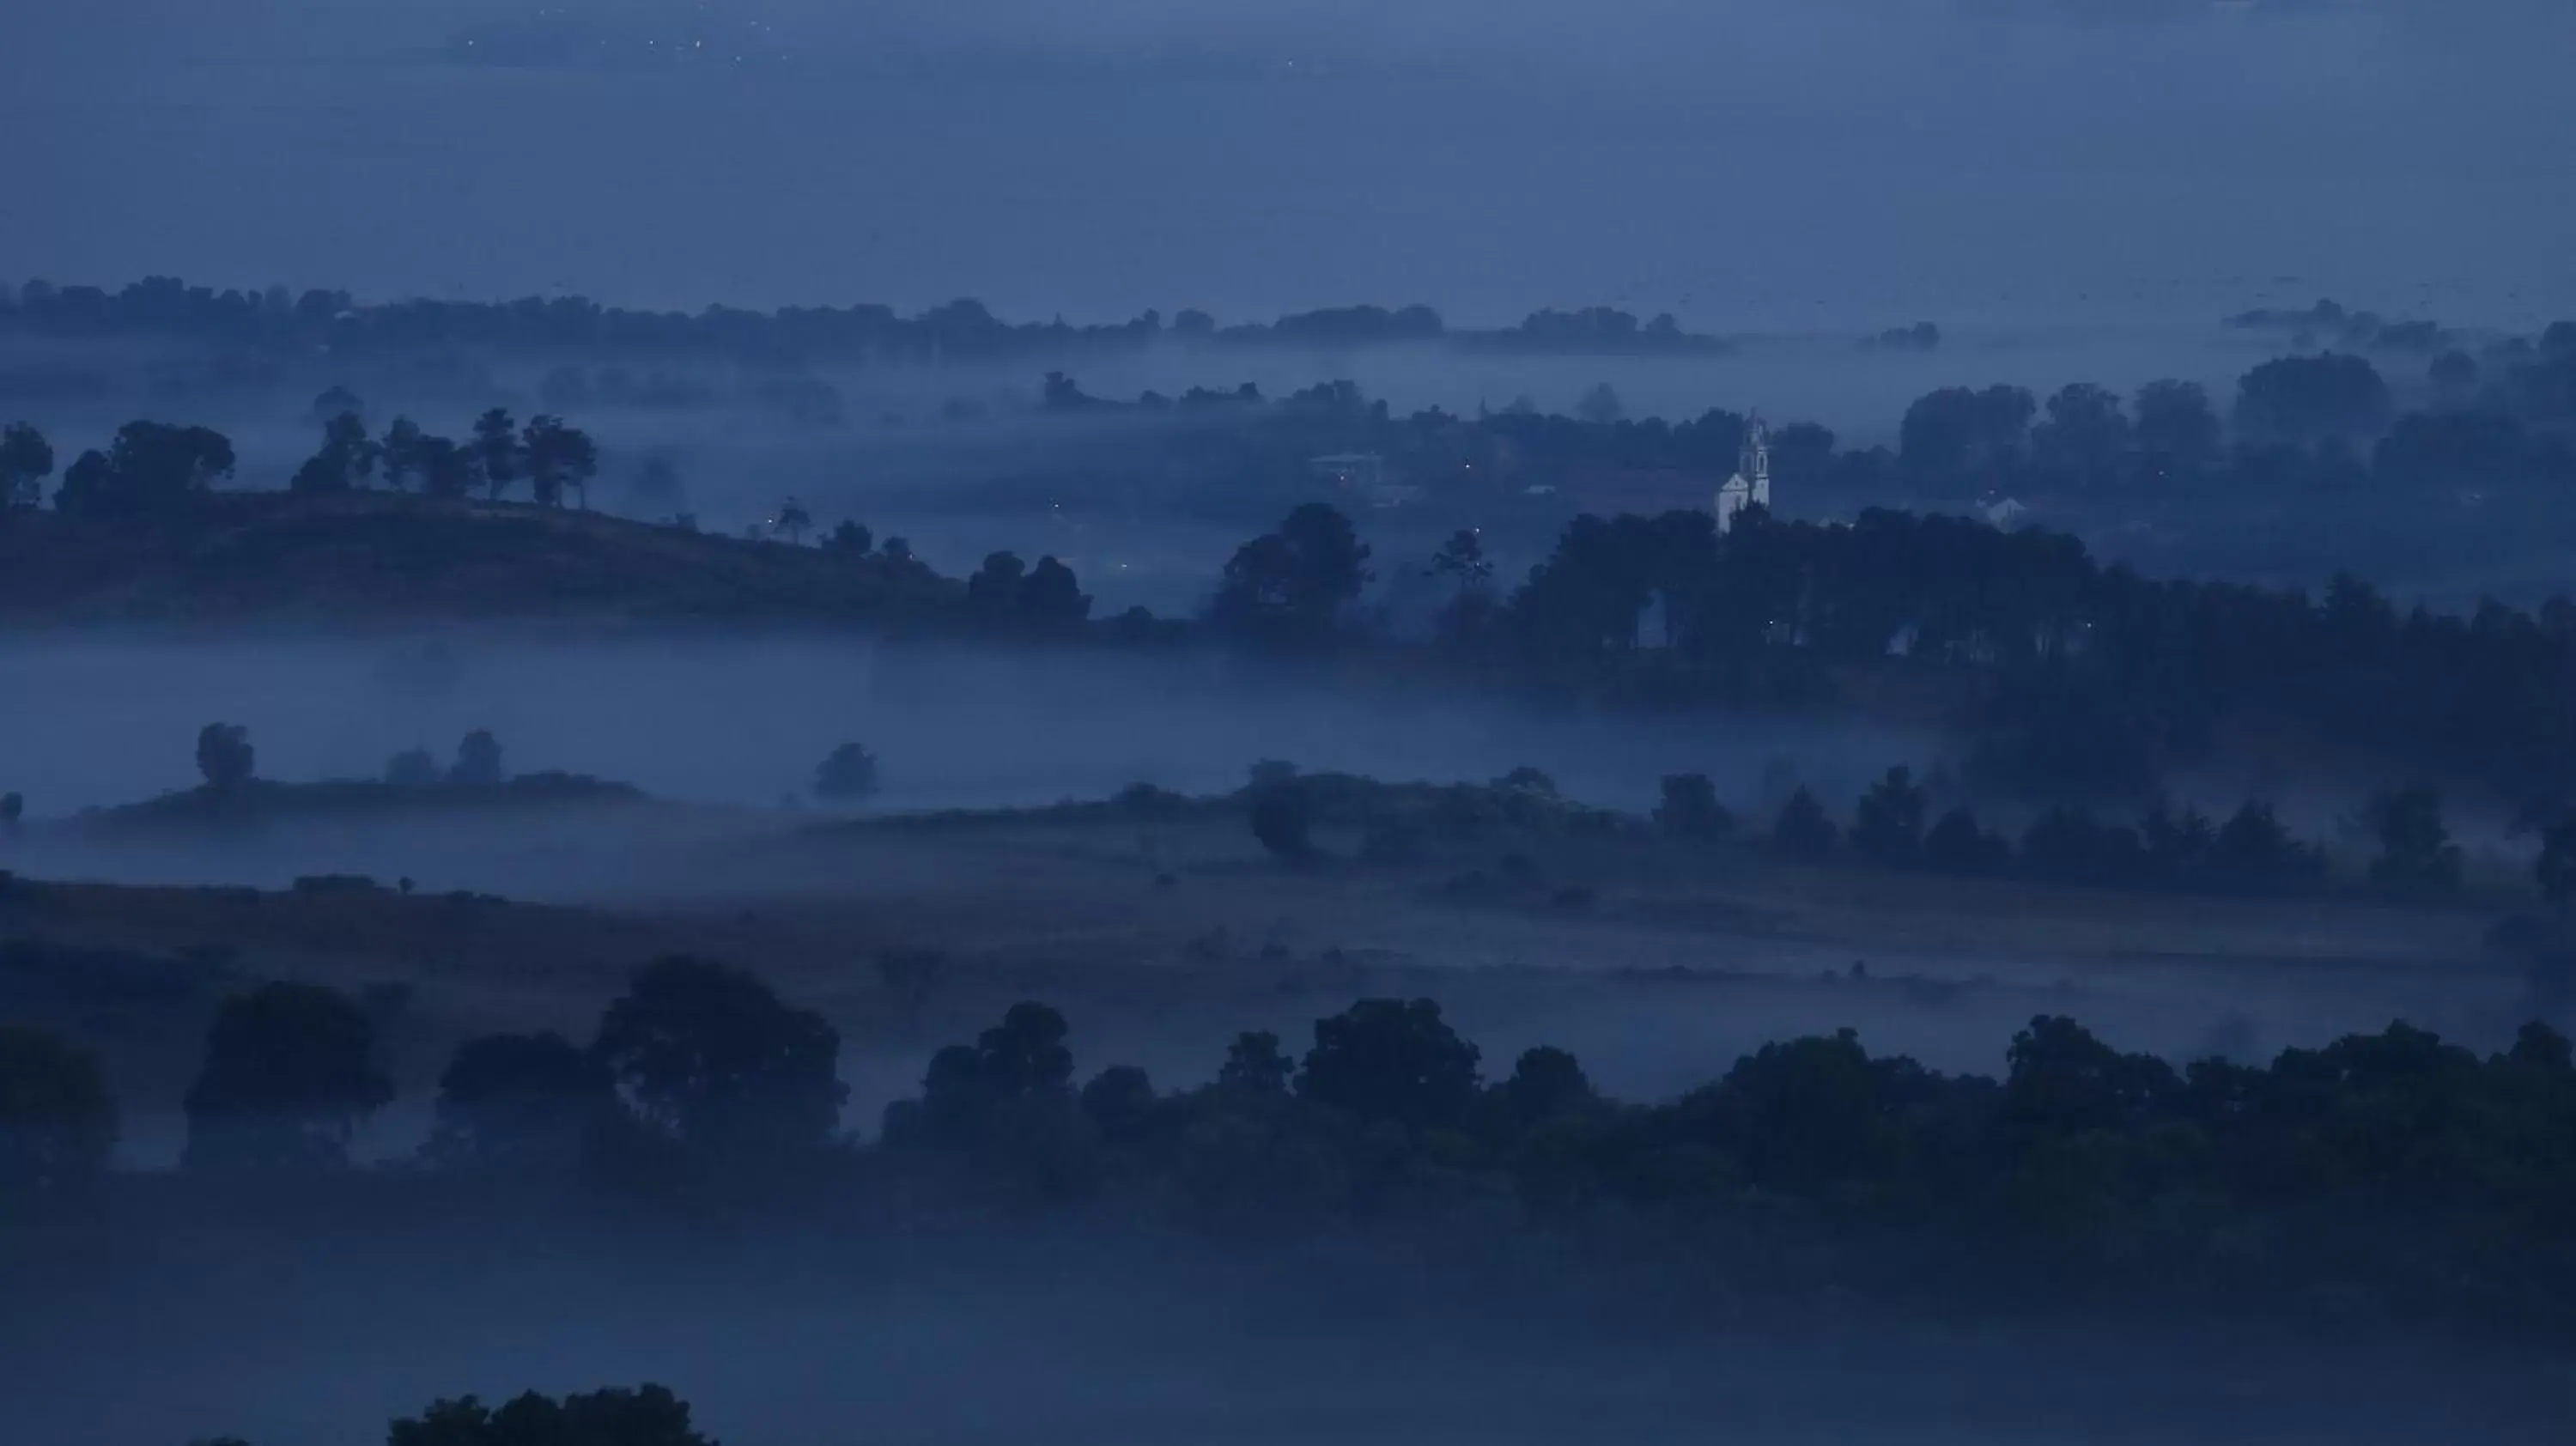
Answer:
1208 492 2576 805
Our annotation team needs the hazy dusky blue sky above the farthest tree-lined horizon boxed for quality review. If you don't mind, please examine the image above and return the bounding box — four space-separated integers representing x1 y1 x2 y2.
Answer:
0 0 2576 330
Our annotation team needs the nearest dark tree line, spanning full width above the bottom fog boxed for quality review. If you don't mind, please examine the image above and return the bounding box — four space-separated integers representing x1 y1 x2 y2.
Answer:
0 944 2576 1330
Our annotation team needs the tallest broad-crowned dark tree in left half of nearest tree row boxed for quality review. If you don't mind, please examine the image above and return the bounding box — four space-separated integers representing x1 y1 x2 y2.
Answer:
590 957 848 1157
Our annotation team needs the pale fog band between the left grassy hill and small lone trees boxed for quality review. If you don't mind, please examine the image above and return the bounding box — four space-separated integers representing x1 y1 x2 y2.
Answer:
0 631 1924 817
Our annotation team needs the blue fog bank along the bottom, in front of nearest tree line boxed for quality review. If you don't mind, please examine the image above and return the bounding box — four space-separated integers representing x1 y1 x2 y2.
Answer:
0 1211 2576 1446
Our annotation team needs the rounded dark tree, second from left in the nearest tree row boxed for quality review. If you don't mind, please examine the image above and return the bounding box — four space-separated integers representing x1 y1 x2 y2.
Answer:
185 982 394 1170
